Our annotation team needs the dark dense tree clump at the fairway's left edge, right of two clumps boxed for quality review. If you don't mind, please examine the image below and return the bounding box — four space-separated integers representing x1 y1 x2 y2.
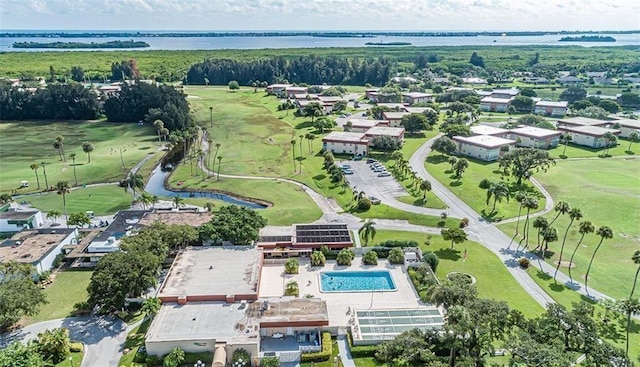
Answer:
104 83 191 131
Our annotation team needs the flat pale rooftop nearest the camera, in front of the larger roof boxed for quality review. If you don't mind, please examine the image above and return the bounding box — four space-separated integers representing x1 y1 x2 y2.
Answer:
146 302 258 342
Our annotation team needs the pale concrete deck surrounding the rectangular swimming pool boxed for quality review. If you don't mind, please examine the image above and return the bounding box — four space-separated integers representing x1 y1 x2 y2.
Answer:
259 257 424 326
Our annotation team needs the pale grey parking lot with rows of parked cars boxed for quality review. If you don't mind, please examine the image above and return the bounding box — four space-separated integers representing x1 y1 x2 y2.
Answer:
338 160 408 203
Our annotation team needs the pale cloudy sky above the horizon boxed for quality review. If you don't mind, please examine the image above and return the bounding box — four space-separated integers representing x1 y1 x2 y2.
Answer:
0 0 640 31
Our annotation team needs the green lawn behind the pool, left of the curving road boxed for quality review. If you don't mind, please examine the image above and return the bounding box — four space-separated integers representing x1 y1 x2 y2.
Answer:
373 230 543 317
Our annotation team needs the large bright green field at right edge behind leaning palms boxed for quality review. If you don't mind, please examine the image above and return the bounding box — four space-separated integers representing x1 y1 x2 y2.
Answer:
499 159 640 298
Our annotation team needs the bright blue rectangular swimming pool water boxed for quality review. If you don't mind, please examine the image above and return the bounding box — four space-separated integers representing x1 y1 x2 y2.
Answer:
320 270 397 292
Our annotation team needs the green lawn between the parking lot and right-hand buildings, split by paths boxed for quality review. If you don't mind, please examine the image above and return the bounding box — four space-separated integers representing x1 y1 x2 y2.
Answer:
425 152 544 220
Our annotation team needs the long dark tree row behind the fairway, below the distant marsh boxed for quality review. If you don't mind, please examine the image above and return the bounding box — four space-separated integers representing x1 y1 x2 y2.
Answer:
184 55 394 85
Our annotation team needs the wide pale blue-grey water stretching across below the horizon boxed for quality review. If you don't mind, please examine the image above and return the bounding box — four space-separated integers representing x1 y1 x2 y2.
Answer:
0 31 640 52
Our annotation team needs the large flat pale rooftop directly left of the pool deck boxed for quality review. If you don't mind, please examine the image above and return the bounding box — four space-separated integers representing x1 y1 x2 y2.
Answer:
158 246 261 297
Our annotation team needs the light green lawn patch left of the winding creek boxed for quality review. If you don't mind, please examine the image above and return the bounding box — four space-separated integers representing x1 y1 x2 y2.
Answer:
24 185 133 215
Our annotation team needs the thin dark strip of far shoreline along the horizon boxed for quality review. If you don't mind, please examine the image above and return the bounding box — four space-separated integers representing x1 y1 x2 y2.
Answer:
0 30 640 38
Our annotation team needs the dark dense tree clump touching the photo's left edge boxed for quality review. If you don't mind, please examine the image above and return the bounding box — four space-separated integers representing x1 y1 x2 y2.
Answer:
0 84 98 120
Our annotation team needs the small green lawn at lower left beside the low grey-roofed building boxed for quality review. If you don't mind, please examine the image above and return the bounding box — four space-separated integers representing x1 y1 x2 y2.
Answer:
24 270 92 325
